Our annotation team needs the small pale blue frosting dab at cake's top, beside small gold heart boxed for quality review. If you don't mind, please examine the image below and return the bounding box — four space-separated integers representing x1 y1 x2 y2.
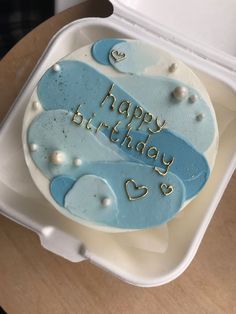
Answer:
109 41 158 74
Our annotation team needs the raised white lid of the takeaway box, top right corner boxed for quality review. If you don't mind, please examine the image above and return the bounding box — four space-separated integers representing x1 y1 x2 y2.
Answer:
111 0 236 71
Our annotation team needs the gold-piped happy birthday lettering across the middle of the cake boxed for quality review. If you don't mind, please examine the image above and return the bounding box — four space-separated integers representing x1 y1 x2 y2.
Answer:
72 84 174 176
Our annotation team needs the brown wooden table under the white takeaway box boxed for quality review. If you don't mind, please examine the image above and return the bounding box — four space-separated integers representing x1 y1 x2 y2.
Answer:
0 1 236 314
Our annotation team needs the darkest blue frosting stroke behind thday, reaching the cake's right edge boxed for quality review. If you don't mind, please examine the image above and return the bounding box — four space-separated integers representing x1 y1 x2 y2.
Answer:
103 129 210 199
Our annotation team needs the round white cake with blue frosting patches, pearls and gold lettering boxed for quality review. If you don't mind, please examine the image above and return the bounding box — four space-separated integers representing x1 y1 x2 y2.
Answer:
22 38 218 231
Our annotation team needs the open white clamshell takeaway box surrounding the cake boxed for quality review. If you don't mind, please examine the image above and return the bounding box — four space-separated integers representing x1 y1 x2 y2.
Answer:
0 0 236 286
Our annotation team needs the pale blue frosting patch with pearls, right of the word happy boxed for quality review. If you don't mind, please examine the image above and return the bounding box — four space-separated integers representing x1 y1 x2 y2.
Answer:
112 75 215 152
